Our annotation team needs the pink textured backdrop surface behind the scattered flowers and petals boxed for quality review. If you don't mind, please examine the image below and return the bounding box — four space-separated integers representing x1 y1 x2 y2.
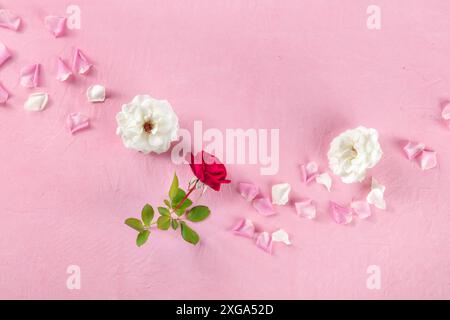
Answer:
0 0 450 299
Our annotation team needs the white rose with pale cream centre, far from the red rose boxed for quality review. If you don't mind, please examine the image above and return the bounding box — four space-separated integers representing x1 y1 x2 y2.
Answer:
328 127 383 183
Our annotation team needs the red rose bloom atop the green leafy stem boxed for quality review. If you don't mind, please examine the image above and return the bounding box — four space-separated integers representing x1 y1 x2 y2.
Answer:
189 151 231 191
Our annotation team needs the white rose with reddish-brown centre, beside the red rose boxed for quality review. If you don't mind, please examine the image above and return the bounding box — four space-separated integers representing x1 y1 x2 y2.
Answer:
116 95 179 154
